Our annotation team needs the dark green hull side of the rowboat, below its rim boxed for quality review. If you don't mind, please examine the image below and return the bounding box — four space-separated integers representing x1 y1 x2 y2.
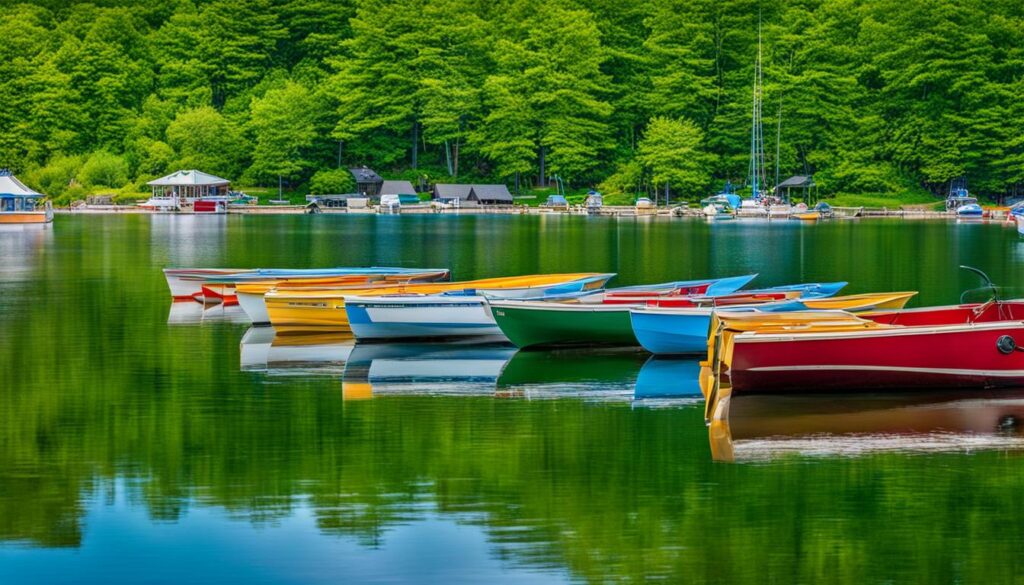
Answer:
490 301 640 347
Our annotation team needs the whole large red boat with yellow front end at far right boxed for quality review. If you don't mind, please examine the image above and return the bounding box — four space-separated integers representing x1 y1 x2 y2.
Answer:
709 300 1024 394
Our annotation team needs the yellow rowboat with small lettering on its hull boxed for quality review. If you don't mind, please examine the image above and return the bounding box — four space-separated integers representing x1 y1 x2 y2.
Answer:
264 273 614 331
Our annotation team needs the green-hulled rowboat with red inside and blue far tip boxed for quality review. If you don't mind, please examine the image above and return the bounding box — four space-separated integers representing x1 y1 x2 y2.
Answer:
490 283 846 348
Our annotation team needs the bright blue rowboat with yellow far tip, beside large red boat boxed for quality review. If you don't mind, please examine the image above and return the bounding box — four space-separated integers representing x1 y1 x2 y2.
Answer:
630 292 918 356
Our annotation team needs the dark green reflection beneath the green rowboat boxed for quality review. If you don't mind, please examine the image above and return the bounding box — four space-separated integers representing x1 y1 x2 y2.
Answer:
498 347 647 402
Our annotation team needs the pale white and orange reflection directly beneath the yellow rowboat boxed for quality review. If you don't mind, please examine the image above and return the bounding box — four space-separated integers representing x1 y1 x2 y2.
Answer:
239 327 355 376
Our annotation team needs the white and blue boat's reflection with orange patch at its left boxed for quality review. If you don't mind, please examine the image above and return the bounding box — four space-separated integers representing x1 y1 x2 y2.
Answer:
342 338 515 400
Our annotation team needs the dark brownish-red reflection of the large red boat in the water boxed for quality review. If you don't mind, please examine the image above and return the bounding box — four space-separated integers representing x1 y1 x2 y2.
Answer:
709 389 1024 461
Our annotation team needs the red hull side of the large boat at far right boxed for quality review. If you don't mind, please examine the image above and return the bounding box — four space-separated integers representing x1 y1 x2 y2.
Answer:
728 322 1024 394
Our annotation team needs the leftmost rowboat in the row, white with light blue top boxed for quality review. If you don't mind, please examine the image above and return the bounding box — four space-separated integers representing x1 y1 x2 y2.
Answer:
164 267 450 300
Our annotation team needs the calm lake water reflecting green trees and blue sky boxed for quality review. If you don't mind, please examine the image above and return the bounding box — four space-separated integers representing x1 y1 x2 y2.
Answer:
0 216 1024 584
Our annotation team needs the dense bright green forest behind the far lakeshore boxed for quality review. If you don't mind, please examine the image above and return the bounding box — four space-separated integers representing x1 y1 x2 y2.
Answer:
0 0 1024 201
